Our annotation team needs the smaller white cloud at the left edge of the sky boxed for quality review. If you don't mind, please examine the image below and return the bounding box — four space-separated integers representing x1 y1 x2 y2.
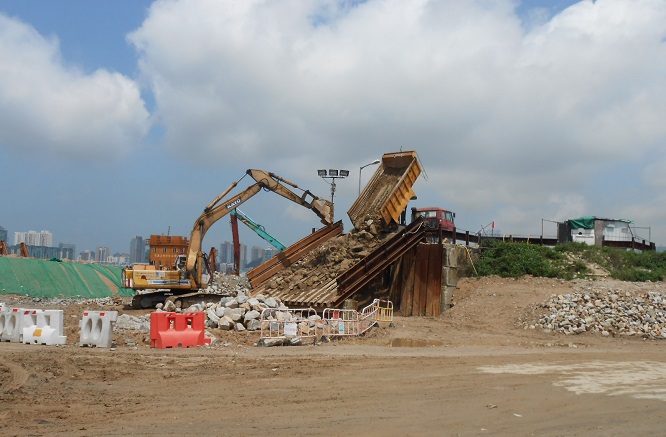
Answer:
0 13 149 159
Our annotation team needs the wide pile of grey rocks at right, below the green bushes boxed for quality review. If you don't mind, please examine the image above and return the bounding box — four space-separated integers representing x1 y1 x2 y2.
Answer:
524 289 666 339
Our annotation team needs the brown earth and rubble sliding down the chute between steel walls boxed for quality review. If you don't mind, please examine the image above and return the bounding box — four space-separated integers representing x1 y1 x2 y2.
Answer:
263 219 386 295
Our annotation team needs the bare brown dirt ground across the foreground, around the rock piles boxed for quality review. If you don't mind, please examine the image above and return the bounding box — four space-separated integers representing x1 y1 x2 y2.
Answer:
0 278 666 436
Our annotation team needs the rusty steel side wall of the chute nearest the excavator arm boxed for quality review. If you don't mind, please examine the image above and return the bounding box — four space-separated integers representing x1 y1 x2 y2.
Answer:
247 220 342 288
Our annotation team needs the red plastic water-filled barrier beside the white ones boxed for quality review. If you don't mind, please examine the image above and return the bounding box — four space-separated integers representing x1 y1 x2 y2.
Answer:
150 312 210 349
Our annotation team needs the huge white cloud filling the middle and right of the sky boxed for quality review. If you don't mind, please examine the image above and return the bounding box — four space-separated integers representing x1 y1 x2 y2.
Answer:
130 0 666 242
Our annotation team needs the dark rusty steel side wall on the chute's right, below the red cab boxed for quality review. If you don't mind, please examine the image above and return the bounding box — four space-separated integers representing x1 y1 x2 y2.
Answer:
332 218 425 307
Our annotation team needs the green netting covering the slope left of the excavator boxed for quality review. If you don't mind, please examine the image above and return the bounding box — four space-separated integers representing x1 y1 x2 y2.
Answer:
0 256 134 298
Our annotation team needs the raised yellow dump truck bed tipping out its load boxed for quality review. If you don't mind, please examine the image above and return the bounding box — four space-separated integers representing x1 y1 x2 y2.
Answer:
347 151 421 229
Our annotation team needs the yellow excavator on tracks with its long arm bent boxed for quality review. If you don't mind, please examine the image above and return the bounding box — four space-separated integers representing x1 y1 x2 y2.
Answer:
122 169 333 308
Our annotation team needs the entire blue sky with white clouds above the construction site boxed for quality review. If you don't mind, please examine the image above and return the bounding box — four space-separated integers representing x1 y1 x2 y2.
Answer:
0 0 666 252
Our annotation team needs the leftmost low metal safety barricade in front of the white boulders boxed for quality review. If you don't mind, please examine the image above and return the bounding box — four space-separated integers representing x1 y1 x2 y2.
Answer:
260 308 318 339
